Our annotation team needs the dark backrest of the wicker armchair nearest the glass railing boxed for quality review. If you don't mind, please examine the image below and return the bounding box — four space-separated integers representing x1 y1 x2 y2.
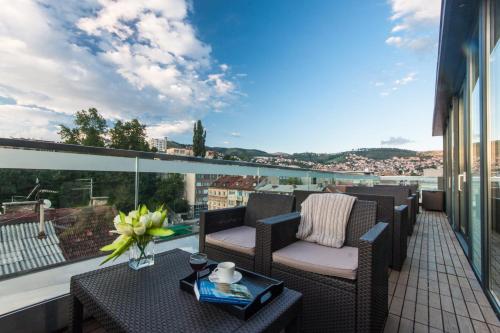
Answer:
244 193 294 227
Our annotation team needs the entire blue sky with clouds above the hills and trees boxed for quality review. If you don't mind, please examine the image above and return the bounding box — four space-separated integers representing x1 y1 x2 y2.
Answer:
0 0 442 153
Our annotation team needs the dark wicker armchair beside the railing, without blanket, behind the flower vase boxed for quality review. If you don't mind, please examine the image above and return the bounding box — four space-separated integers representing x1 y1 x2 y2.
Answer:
199 193 294 271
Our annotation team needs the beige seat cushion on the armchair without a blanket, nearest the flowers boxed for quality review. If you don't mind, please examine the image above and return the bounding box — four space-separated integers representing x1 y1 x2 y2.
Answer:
205 226 255 255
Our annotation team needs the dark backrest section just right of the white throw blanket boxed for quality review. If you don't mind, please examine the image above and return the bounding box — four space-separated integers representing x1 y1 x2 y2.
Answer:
344 200 377 247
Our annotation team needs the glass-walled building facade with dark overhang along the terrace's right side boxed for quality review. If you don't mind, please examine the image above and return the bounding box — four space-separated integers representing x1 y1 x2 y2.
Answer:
433 0 500 313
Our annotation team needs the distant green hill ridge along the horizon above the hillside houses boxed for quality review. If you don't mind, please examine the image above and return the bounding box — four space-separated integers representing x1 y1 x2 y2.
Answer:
168 141 442 163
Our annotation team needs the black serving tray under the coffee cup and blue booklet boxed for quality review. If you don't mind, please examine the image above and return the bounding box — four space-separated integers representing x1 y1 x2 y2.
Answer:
179 264 284 320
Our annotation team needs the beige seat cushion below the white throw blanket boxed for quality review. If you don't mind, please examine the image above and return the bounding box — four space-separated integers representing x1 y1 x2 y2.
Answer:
273 241 358 280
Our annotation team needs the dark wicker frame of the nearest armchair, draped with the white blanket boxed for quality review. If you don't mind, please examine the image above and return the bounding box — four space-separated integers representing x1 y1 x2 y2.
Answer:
257 200 389 332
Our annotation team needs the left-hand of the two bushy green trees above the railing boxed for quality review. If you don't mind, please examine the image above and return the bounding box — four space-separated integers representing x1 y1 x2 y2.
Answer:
59 108 108 147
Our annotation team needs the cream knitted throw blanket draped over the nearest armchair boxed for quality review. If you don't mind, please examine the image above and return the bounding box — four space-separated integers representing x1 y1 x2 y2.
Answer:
297 193 356 248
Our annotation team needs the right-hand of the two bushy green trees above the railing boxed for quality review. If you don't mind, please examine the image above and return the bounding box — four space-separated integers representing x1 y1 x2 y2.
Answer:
109 119 150 151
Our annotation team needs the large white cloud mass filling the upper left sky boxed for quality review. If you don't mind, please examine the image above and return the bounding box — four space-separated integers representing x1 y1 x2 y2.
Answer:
0 0 237 138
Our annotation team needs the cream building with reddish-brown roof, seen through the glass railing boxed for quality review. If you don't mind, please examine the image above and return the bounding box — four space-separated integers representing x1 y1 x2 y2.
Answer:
208 176 265 210
